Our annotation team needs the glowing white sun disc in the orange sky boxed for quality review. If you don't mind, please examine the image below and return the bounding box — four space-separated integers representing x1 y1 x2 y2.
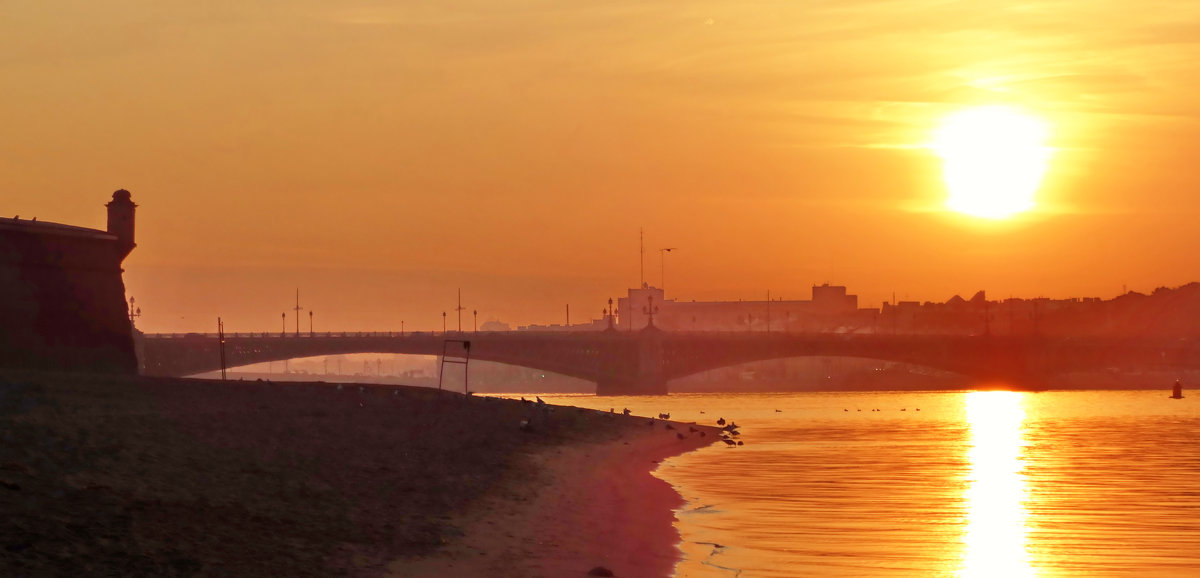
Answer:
930 107 1051 219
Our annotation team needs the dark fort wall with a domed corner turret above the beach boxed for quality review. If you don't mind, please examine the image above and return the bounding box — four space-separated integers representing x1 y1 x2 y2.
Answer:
0 189 138 373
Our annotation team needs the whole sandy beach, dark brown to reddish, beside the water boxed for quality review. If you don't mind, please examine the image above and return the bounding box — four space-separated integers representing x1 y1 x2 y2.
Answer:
0 373 716 578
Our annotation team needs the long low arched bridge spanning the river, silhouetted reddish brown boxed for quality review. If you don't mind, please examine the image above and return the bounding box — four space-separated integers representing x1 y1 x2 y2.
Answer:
133 326 1200 395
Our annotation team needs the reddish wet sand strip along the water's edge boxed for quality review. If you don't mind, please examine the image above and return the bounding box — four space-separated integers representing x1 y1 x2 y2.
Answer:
389 417 718 578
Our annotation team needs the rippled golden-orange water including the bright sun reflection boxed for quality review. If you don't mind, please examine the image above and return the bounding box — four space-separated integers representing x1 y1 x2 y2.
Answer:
542 391 1200 578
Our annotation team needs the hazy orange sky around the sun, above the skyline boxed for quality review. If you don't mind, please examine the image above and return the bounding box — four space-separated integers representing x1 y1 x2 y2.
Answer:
0 0 1200 331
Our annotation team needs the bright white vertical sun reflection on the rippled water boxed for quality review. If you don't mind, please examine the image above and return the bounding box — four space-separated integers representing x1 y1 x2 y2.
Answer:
959 391 1036 577
